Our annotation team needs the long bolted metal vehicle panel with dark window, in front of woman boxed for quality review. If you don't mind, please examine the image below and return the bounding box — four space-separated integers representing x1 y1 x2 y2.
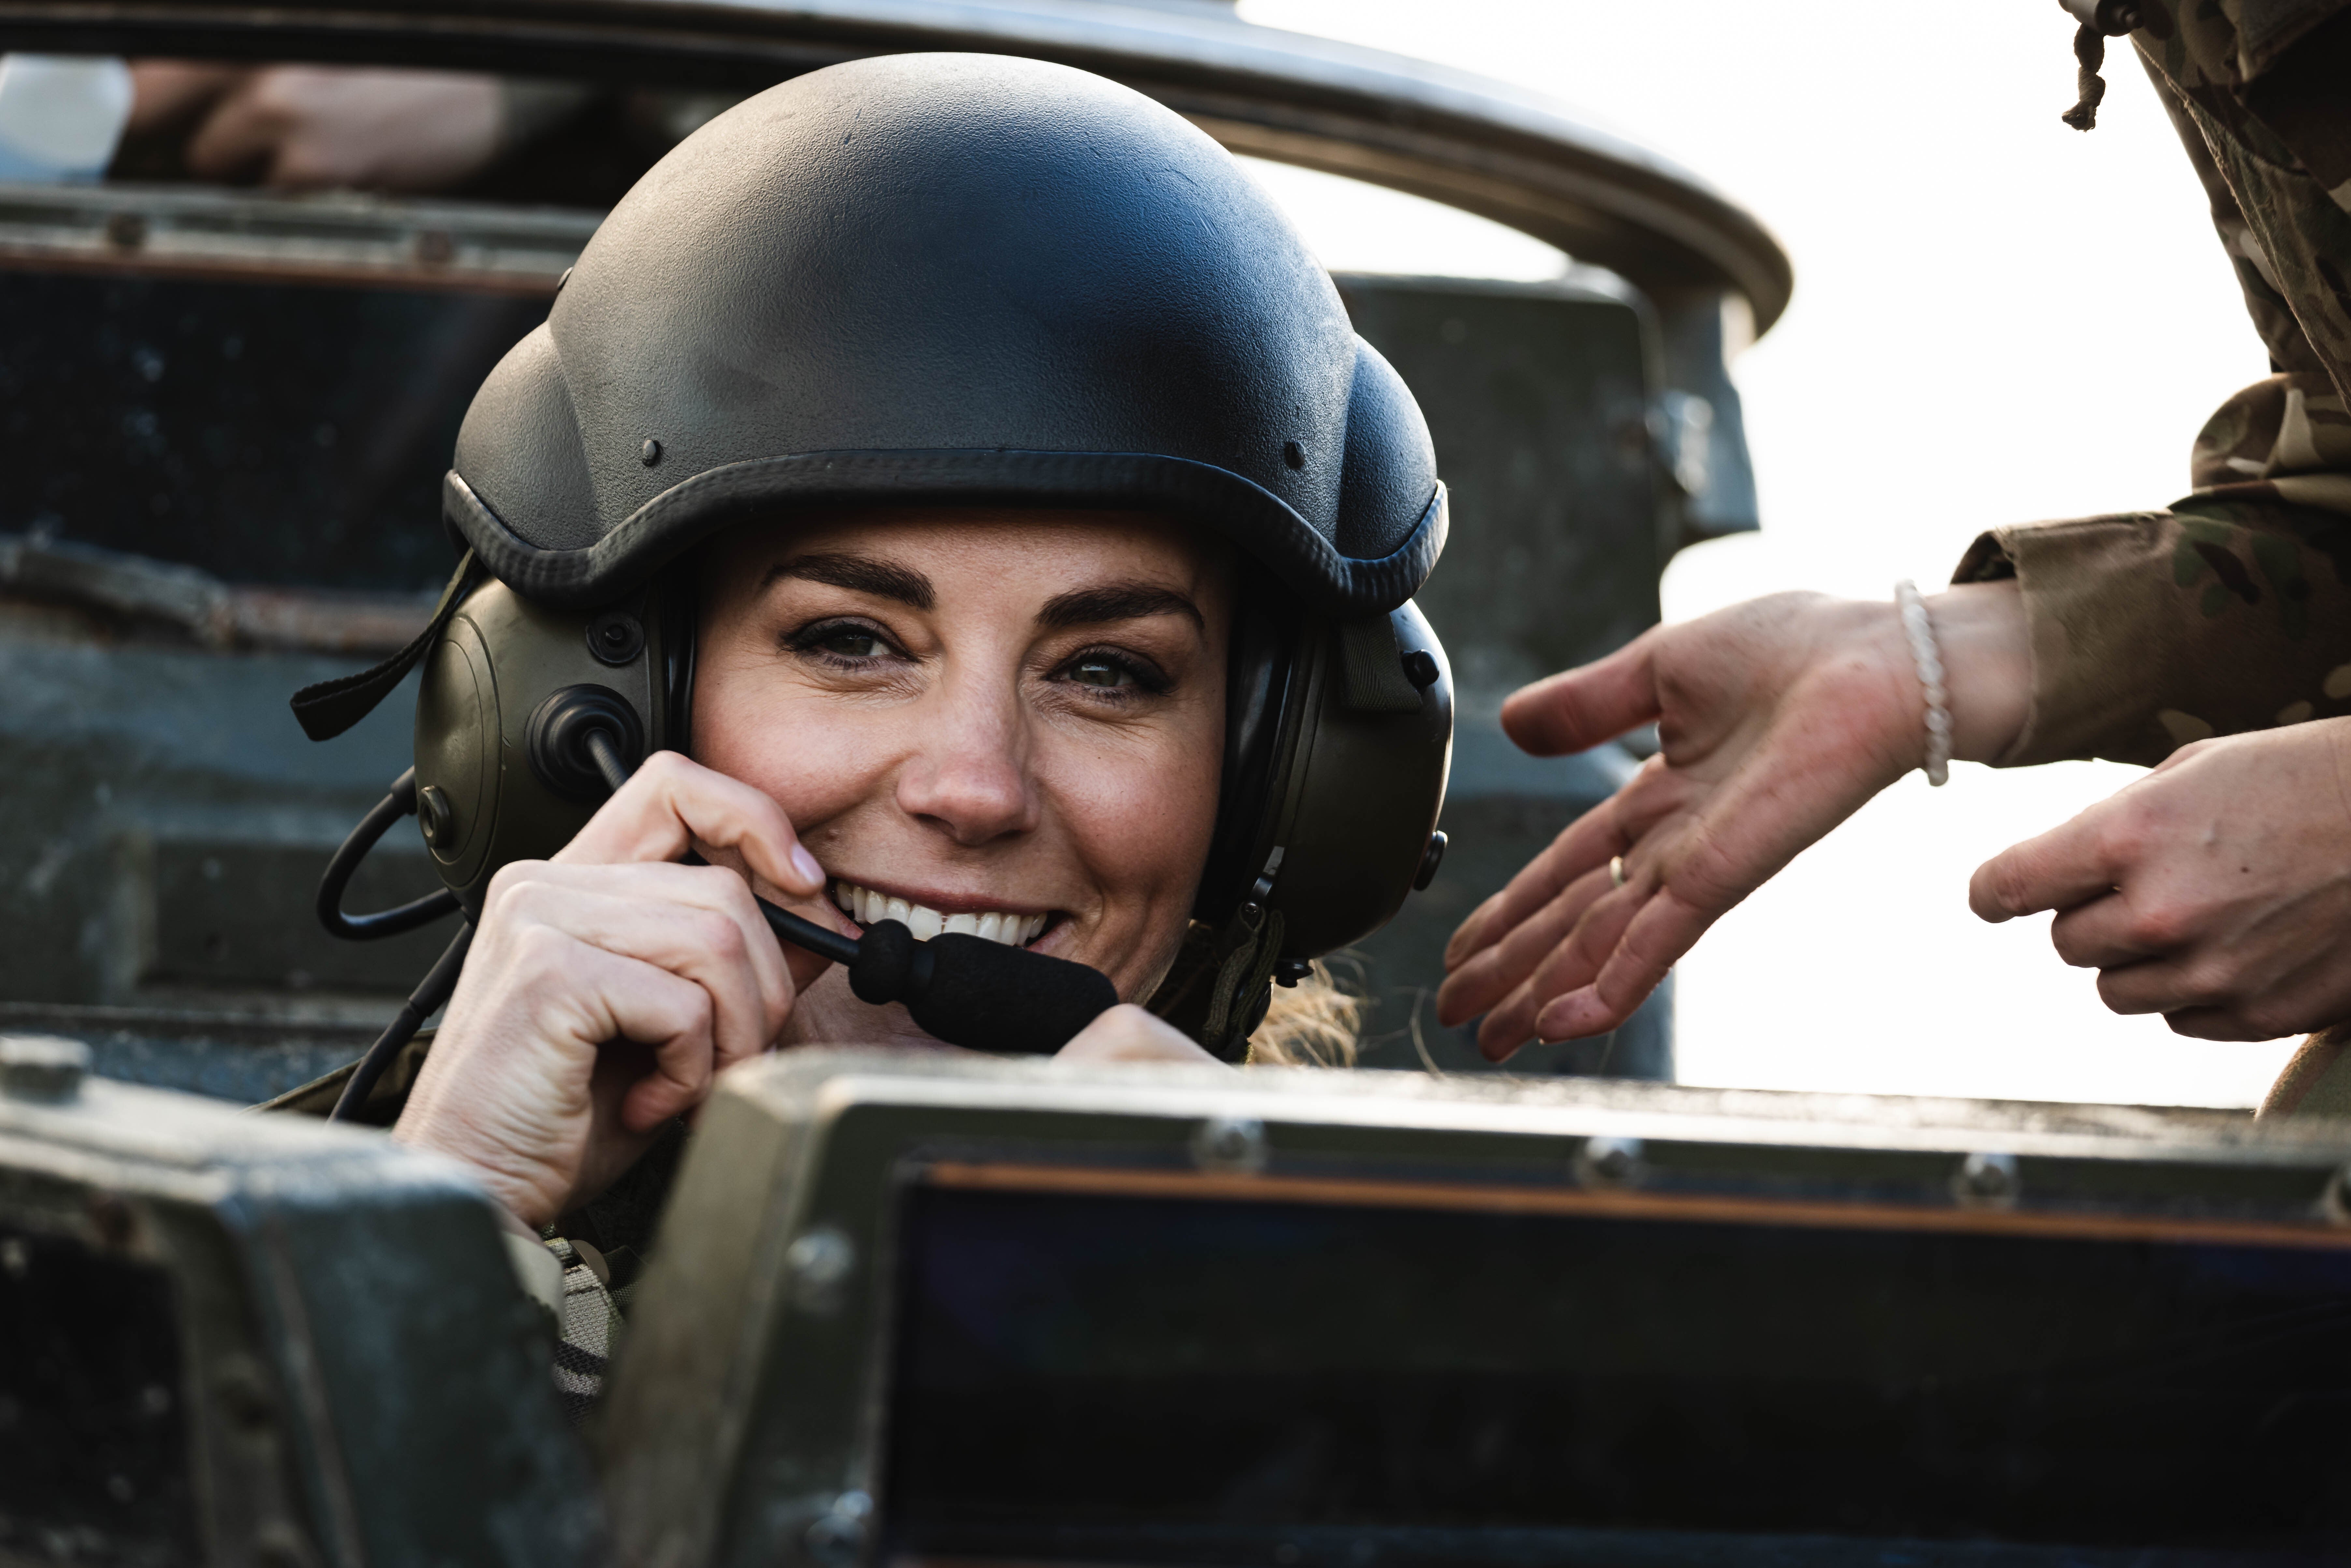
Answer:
604 1051 2351 1563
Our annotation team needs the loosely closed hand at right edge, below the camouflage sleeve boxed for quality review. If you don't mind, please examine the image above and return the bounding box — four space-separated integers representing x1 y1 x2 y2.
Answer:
1968 720 2351 1039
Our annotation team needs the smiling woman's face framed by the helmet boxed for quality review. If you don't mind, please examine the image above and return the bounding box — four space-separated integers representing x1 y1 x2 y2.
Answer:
694 510 1232 1041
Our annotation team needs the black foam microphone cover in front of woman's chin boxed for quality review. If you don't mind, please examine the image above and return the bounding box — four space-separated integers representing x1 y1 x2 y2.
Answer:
849 919 1119 1056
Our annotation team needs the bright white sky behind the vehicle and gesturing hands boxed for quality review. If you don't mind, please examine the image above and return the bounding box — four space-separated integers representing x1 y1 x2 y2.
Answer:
1241 0 2292 1105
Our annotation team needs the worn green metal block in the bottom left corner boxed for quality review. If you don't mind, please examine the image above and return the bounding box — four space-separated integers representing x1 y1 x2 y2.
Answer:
0 1062 599 1568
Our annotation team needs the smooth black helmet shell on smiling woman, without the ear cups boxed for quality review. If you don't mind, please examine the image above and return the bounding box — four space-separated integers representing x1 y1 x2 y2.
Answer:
449 54 1443 616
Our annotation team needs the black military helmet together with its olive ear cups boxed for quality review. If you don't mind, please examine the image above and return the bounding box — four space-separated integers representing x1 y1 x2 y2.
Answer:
296 54 1451 1053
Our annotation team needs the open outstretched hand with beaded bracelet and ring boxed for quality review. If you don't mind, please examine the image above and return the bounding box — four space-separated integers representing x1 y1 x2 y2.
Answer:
1437 583 2031 1060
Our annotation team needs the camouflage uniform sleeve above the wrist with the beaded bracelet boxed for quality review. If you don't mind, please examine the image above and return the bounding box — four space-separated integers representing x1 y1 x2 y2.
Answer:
1954 0 2351 766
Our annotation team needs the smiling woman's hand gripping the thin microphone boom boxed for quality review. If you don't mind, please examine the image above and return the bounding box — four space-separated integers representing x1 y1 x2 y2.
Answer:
393 752 825 1230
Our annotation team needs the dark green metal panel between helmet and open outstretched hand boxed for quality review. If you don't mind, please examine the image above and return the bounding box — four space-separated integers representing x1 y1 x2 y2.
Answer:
1338 275 1681 1079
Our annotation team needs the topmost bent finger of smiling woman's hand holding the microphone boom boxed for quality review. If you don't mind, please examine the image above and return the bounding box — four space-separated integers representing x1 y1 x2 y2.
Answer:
555 752 825 898
